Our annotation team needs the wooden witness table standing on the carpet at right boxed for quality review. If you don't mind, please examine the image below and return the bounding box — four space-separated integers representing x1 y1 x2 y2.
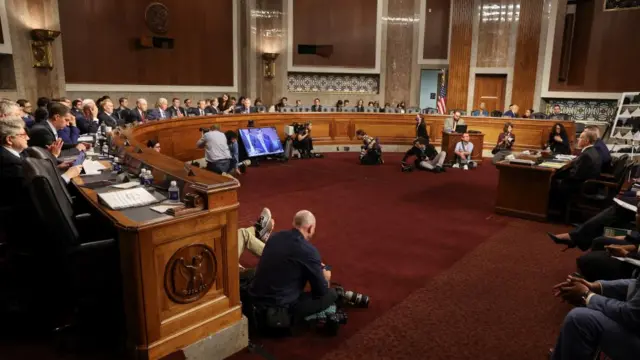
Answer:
495 160 566 221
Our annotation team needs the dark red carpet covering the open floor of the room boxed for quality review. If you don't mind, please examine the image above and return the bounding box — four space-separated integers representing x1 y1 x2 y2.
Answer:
233 154 575 360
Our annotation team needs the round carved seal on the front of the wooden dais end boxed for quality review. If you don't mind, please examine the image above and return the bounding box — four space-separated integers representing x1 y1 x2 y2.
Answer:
164 244 217 304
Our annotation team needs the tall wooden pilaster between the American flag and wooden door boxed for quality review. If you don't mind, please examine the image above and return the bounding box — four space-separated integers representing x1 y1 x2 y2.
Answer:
447 0 474 109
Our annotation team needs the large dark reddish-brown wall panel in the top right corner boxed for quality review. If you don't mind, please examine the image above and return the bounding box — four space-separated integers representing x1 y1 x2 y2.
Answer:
549 0 640 92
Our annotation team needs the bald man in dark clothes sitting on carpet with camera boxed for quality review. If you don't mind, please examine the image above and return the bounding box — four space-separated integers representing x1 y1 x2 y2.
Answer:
249 210 338 322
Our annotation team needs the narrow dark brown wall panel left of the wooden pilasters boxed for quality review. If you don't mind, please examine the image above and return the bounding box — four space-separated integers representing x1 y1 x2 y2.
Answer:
420 0 451 59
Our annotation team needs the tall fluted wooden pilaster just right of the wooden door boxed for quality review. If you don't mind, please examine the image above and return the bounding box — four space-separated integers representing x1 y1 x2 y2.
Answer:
511 0 543 109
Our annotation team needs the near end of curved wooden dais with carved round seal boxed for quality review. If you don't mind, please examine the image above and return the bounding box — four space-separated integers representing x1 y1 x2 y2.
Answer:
74 129 248 360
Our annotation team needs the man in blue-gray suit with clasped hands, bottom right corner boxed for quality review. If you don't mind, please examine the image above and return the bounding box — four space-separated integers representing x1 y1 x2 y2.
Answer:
551 245 640 360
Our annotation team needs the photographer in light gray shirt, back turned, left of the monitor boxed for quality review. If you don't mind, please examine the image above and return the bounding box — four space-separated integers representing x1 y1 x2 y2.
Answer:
196 124 236 175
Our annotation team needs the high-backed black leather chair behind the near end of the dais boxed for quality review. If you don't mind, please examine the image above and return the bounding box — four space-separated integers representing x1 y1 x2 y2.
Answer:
23 158 120 338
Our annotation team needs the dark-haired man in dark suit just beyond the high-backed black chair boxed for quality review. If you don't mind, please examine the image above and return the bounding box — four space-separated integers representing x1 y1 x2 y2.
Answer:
29 103 87 155
